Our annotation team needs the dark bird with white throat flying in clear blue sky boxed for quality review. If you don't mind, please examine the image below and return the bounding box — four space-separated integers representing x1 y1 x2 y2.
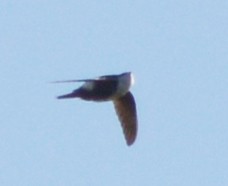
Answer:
54 72 137 146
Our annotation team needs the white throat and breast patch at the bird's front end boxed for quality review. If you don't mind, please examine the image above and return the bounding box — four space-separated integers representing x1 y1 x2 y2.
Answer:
116 73 134 96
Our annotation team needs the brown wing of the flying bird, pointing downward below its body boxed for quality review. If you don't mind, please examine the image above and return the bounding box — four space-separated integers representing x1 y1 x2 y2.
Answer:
114 92 137 145
